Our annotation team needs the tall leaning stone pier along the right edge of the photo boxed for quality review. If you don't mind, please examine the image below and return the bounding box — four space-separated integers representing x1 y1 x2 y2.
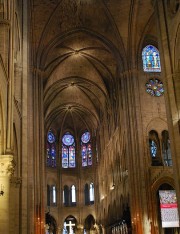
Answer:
154 0 180 208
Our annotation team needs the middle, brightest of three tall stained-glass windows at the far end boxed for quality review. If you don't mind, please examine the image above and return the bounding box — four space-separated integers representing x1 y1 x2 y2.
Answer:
62 132 76 168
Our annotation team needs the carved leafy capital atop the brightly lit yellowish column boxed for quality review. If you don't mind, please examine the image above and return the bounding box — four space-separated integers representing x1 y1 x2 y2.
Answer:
0 155 15 176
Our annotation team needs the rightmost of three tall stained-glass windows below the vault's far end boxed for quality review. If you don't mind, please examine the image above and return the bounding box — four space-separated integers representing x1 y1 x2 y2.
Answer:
81 131 92 167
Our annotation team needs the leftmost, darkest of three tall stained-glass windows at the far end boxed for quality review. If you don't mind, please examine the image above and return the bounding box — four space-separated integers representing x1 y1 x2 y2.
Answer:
46 130 56 168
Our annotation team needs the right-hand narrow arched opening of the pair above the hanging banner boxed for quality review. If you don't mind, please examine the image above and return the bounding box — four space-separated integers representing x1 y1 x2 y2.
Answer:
162 130 172 166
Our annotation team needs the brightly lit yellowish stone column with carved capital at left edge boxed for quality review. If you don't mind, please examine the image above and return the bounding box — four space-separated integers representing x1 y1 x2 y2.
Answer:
0 155 14 234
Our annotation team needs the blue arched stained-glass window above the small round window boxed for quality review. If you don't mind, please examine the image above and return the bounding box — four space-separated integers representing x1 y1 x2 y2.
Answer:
142 45 161 72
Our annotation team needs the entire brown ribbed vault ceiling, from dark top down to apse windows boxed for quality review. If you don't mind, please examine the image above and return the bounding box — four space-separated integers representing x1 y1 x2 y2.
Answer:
32 0 128 134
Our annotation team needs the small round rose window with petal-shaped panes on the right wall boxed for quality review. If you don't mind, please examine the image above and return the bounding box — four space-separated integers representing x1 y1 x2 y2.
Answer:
145 78 164 97
